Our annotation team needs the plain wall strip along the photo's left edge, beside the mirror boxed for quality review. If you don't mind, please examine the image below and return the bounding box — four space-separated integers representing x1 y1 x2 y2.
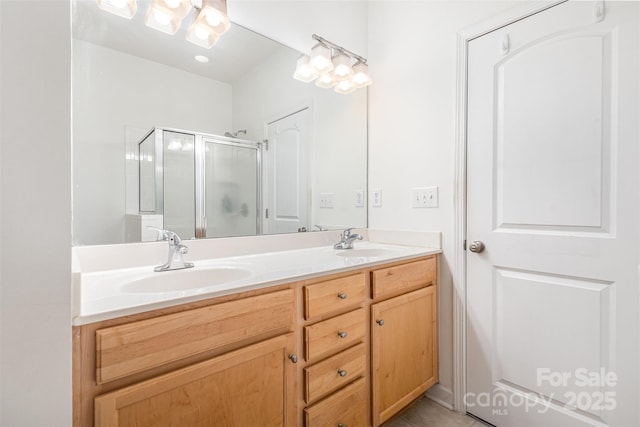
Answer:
0 0 71 427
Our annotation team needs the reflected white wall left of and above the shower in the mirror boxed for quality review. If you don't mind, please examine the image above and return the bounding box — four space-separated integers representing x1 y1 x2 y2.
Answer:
73 39 232 245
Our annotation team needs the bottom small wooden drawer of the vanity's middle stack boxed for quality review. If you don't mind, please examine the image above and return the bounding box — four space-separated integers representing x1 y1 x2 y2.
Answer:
304 378 368 427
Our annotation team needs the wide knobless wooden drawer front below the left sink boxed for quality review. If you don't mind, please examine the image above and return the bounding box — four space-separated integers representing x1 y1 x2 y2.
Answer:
96 289 294 384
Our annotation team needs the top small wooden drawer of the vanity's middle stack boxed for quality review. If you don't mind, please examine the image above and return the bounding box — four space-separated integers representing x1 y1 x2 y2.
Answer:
304 273 367 319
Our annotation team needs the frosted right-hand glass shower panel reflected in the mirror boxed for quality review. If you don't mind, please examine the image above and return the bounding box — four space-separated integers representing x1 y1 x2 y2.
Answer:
204 139 260 237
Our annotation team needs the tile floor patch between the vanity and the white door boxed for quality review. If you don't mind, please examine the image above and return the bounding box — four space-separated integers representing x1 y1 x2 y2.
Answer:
385 397 486 427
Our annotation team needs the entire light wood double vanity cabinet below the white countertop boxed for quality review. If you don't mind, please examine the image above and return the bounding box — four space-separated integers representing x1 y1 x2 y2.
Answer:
73 255 438 427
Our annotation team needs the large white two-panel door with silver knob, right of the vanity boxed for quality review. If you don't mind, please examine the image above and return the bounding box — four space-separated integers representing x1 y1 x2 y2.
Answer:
465 1 640 427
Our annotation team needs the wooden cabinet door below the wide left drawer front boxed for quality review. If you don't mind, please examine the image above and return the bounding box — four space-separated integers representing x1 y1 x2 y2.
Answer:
95 334 295 427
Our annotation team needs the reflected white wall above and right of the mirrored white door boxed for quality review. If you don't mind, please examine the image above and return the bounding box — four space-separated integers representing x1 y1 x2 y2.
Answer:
233 48 367 229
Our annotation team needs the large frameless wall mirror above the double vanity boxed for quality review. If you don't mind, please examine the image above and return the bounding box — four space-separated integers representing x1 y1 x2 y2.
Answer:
72 0 367 245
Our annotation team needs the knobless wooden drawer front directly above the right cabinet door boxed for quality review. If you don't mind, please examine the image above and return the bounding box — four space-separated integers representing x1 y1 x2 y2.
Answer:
371 256 437 298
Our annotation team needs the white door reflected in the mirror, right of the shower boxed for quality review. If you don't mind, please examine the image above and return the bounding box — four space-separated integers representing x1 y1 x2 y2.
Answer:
264 108 309 234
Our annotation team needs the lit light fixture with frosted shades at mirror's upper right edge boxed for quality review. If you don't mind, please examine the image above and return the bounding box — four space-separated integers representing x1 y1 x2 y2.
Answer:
293 34 371 95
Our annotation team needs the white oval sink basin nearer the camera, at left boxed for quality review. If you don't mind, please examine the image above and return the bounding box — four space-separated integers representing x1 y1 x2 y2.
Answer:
121 267 251 294
